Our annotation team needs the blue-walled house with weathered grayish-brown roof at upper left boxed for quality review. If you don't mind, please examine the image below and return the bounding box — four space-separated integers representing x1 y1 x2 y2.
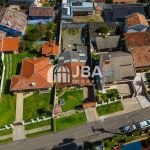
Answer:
0 7 27 36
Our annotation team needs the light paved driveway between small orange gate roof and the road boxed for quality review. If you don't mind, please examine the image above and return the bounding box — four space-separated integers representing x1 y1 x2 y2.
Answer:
84 107 99 122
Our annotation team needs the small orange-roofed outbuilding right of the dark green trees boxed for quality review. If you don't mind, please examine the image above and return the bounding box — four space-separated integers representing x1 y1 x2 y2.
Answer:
42 40 59 56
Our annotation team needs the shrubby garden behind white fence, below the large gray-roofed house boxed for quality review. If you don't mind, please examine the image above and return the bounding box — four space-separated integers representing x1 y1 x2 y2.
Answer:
96 89 120 103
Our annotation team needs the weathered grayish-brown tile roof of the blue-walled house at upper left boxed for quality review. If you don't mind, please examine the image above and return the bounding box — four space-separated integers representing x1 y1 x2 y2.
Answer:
0 7 27 32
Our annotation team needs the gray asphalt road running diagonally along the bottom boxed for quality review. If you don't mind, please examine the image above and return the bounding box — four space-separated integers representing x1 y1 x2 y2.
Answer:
0 108 150 150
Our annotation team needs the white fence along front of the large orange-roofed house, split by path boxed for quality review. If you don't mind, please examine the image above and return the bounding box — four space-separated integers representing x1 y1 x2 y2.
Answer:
0 116 52 131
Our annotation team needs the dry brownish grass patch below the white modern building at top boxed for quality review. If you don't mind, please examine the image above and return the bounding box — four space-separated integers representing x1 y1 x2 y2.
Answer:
73 14 104 22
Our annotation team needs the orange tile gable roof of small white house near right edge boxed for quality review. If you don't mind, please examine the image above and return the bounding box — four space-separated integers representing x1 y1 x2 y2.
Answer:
126 13 149 27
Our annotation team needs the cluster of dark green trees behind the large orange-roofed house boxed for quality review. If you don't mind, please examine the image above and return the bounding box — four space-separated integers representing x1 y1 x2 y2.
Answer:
19 22 57 52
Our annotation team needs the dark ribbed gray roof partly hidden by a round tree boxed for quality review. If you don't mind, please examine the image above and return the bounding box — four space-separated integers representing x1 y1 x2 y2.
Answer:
89 22 117 38
